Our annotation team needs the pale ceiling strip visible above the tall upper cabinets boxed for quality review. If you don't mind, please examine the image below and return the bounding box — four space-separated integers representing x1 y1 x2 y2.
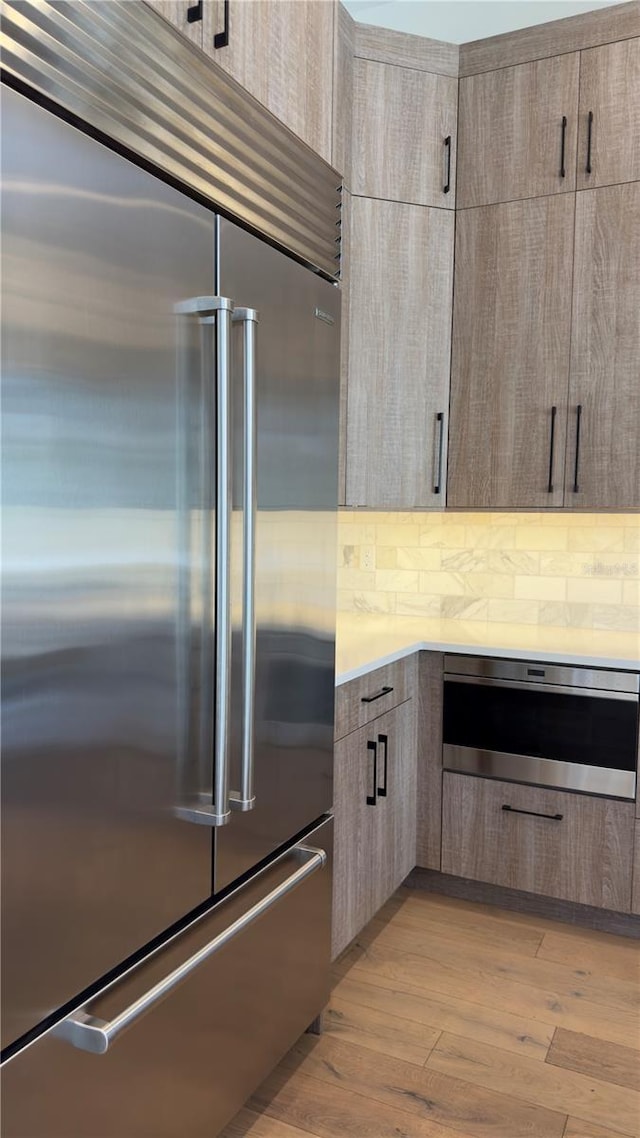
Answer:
343 0 620 43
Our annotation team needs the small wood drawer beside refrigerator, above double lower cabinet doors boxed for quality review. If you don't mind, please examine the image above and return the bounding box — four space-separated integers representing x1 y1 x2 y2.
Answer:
335 657 413 739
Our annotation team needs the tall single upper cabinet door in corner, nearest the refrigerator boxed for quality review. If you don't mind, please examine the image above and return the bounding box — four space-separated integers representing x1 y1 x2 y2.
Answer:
346 197 453 510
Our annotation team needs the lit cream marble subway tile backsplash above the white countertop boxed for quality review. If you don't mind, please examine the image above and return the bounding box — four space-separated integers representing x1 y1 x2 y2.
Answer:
338 510 640 632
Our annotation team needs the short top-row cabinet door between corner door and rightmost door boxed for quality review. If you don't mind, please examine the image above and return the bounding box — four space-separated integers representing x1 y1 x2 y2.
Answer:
458 51 580 208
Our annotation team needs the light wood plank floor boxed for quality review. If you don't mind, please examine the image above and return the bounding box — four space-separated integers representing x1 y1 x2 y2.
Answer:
222 889 640 1138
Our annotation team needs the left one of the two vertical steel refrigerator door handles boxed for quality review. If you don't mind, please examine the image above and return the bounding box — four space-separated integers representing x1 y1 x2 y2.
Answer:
174 296 233 826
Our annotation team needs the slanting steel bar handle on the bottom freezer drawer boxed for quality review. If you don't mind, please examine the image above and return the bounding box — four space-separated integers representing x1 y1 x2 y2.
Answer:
52 846 327 1055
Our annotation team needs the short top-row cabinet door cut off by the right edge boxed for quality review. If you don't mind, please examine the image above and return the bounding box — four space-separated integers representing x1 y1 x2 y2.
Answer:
577 39 640 189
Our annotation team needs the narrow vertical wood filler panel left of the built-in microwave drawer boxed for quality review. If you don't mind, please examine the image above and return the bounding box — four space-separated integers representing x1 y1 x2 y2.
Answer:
416 652 443 869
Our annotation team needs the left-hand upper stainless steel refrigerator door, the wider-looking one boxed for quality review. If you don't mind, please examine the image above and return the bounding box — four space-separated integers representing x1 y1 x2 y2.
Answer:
2 89 215 1044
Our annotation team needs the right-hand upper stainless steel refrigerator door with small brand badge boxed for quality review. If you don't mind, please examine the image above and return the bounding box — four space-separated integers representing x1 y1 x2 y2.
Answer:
214 220 340 890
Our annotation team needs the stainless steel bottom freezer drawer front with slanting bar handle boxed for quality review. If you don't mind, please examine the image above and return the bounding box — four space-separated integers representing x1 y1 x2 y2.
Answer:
2 820 333 1138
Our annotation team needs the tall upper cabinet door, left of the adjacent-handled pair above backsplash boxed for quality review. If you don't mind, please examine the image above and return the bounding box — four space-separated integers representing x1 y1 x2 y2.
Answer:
448 193 575 510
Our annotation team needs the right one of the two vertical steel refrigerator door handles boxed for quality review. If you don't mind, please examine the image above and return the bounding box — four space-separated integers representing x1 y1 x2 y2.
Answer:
229 308 260 810
